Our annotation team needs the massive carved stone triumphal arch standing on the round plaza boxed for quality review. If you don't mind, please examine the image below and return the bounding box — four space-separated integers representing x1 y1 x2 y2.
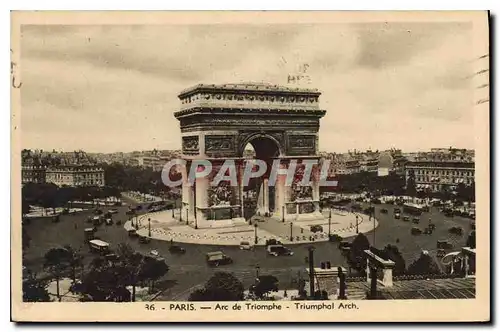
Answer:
174 83 326 228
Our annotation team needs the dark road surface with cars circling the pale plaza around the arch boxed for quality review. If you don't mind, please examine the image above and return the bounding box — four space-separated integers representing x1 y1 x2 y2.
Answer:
23 200 470 300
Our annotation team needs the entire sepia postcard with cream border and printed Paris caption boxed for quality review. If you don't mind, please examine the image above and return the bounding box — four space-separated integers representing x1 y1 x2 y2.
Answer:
10 11 490 322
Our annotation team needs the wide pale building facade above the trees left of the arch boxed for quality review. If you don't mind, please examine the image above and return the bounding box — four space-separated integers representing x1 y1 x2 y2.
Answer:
46 165 105 187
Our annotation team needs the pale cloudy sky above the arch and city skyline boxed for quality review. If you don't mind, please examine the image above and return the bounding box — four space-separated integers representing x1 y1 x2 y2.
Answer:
19 22 474 152
